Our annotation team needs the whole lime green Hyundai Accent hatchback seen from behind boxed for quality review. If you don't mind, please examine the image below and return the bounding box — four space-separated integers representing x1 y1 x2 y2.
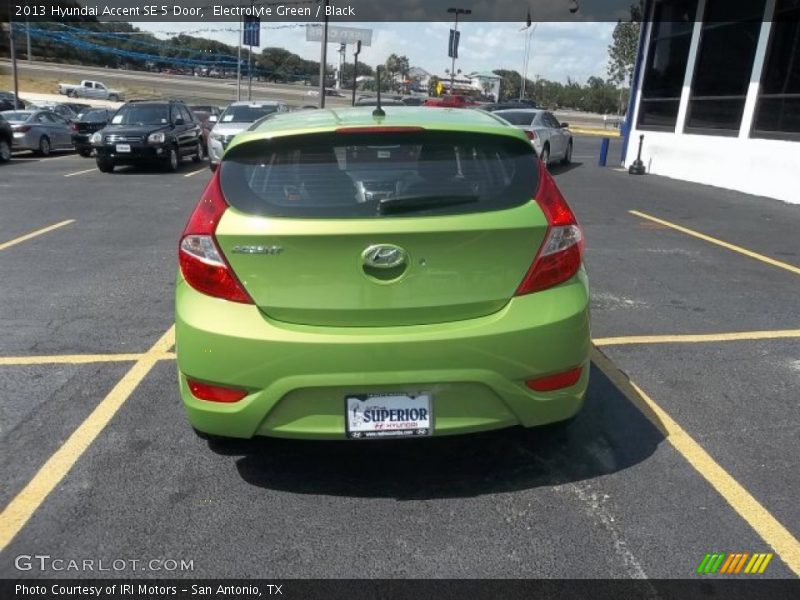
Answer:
176 107 590 440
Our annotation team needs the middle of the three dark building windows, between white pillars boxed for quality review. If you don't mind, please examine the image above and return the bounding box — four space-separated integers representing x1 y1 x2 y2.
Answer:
686 0 766 135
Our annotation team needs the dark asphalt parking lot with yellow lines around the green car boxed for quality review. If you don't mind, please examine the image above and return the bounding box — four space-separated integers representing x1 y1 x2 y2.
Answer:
0 137 800 578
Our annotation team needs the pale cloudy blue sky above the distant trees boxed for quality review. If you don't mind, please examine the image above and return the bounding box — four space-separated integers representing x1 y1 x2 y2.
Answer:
132 21 616 83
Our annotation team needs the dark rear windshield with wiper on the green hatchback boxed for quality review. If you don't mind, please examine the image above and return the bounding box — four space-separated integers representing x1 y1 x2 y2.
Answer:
220 131 538 218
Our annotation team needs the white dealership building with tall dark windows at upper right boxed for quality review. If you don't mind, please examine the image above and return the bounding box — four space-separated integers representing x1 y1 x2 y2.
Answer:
624 0 800 203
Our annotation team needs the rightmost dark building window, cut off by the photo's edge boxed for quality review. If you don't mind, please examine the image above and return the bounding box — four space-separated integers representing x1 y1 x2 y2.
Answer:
752 0 800 140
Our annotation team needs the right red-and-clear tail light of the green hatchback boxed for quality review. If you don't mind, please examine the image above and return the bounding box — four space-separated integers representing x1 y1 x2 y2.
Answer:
516 162 584 296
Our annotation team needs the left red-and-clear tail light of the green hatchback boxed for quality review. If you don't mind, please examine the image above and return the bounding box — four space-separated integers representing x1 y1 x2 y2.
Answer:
178 169 253 304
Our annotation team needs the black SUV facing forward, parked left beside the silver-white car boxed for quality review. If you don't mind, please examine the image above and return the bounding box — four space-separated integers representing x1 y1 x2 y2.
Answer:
91 100 203 173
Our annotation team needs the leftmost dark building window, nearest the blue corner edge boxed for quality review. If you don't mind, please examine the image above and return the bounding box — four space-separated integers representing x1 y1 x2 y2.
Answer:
637 0 697 131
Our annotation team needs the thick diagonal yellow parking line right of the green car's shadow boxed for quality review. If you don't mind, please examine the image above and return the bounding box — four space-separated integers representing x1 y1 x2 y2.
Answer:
592 348 800 575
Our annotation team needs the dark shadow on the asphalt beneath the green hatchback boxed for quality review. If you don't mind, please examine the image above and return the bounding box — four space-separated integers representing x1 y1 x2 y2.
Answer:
209 356 664 500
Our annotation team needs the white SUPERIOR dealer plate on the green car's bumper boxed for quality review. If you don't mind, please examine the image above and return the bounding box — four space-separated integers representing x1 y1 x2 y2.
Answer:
345 393 433 439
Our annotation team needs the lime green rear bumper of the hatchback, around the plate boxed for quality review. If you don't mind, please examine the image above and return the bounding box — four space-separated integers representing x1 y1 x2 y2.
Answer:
176 271 591 439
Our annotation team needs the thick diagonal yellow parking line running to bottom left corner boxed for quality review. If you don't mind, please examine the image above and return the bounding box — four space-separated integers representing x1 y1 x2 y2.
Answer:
0 326 175 551
